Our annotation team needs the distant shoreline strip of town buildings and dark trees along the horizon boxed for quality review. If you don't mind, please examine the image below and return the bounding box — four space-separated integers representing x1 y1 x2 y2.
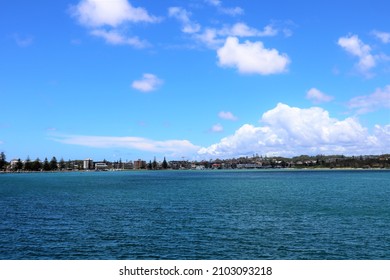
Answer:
0 152 390 173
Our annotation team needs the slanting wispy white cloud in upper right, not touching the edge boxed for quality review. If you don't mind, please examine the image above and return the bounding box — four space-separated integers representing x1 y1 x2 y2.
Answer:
338 35 376 73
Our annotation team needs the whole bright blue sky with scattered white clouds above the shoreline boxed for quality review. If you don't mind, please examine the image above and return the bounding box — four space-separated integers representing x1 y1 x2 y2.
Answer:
0 0 390 161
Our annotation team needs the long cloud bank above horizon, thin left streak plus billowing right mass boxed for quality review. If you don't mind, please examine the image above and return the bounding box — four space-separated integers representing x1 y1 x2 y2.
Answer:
52 103 390 159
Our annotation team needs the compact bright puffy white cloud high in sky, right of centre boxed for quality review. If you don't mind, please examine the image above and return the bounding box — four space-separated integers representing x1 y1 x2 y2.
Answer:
217 37 290 75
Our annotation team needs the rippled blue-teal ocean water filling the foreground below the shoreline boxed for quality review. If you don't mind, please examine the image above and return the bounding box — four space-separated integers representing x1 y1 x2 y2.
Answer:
0 170 390 260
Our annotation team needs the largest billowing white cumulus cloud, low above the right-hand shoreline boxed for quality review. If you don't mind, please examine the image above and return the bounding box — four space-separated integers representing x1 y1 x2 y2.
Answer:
198 103 390 157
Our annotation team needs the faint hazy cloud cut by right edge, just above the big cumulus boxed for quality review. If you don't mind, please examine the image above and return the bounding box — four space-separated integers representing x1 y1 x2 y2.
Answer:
348 85 390 114
